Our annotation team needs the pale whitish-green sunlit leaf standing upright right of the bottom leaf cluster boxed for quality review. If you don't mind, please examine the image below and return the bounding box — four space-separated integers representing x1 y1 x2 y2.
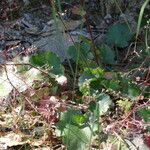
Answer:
97 93 112 115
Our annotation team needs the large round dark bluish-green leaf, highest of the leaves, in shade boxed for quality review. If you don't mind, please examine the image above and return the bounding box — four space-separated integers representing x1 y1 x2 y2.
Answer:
106 23 132 48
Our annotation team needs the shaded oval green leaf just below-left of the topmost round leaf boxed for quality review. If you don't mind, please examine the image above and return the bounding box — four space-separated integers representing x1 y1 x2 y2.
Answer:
99 45 115 64
